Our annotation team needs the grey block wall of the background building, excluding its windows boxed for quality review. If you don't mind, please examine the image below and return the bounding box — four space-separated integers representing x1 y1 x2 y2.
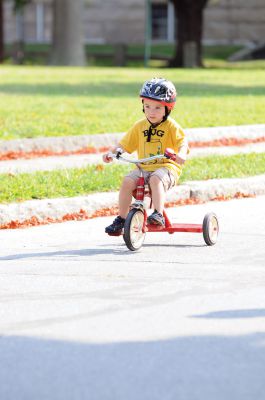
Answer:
4 0 265 44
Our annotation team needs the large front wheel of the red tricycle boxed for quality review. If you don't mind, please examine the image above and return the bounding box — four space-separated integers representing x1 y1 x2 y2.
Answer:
123 209 145 251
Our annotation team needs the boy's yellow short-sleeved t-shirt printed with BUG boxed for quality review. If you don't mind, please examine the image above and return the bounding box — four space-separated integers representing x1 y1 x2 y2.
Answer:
120 117 186 180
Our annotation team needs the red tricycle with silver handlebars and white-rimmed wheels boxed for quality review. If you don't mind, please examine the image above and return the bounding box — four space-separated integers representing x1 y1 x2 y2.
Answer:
105 149 219 251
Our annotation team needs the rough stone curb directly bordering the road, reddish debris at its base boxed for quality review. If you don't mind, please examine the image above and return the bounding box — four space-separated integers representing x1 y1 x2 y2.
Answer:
0 174 265 229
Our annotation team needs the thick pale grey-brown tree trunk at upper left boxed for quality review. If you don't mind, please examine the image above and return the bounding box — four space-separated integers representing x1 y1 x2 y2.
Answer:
51 0 86 66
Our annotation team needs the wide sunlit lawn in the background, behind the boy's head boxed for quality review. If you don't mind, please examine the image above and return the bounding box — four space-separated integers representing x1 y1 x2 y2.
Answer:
0 63 265 139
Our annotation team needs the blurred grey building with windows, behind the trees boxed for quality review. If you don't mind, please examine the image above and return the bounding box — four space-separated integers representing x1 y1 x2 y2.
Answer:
4 0 265 44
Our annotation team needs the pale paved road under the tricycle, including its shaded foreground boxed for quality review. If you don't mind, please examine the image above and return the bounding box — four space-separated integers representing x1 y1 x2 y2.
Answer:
0 196 265 400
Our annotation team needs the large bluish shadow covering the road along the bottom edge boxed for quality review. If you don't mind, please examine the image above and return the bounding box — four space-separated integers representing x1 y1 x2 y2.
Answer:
0 332 265 400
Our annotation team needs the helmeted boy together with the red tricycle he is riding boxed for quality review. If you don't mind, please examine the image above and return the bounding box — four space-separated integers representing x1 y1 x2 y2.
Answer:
103 78 218 250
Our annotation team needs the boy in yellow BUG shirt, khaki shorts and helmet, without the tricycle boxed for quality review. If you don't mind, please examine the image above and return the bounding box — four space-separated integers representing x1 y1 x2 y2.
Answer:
103 78 189 234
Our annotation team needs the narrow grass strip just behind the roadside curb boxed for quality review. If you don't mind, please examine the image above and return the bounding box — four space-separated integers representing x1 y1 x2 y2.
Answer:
0 154 265 203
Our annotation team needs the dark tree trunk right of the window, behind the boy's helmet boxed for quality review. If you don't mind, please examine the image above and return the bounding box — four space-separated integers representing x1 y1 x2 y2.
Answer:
169 0 208 67
